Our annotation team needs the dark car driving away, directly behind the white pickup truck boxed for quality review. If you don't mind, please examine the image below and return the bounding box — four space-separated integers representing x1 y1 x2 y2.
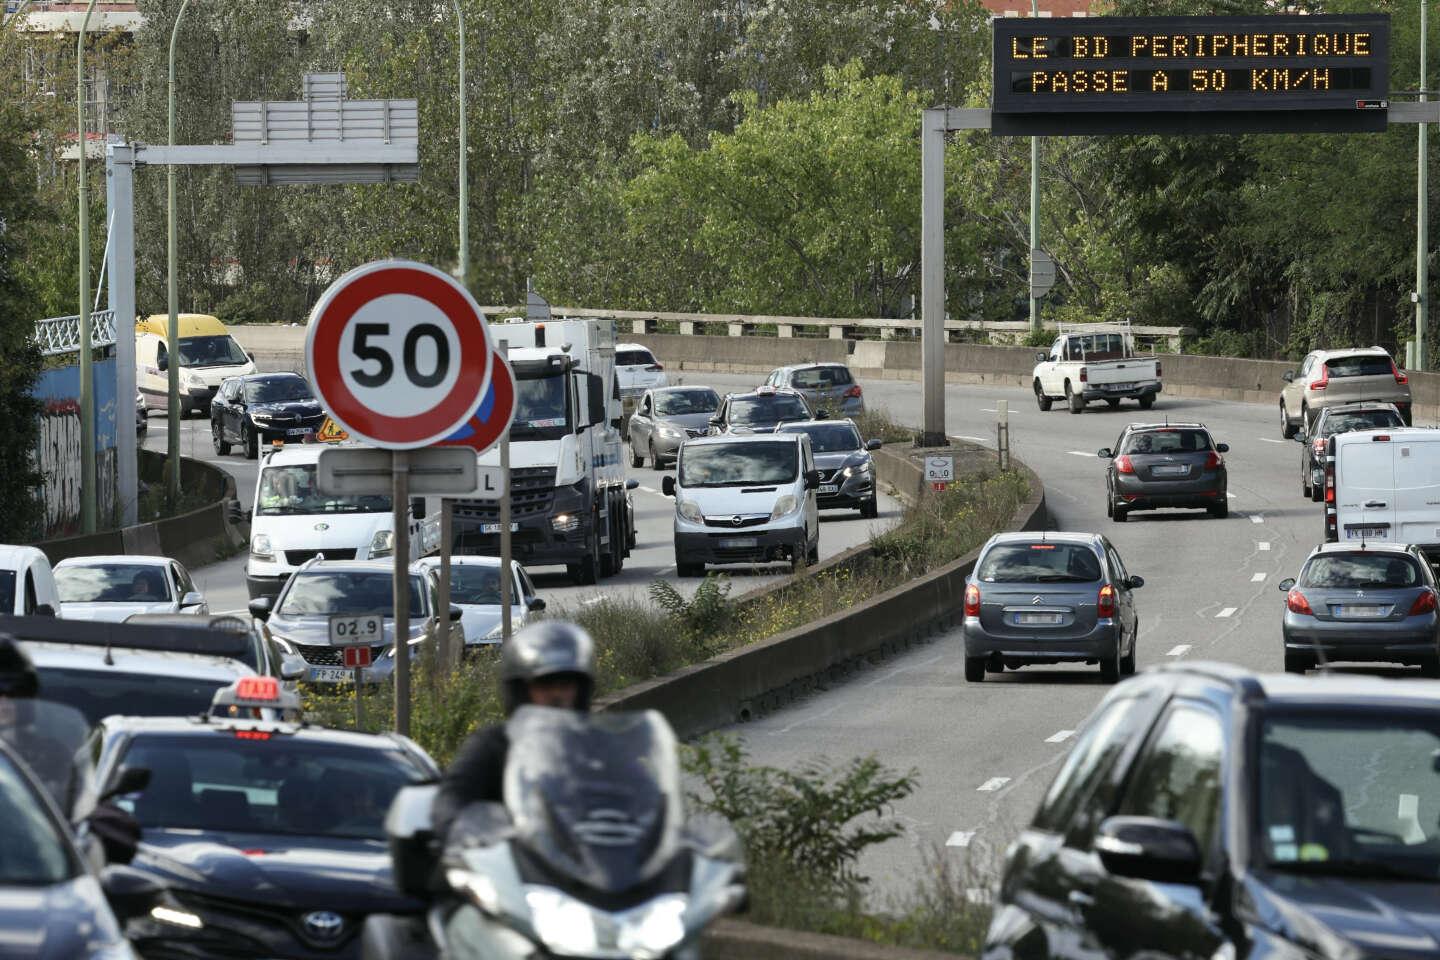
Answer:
1096 423 1230 524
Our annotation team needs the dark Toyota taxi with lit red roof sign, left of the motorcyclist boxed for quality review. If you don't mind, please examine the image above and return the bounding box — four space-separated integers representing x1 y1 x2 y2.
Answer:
95 678 439 960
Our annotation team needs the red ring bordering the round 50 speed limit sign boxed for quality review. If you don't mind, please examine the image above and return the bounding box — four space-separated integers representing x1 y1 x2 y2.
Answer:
307 266 491 448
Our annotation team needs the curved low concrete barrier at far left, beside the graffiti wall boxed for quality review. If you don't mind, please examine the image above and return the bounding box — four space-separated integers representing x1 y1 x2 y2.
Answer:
35 450 245 567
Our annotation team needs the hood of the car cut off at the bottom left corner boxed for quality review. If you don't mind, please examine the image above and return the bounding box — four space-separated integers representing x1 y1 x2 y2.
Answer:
0 874 128 960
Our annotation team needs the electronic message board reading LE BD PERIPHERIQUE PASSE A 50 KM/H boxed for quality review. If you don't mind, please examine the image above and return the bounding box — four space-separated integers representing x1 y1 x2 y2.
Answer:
991 14 1390 135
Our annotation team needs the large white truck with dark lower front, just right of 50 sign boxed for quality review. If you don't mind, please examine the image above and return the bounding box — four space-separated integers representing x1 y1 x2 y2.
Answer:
451 320 636 584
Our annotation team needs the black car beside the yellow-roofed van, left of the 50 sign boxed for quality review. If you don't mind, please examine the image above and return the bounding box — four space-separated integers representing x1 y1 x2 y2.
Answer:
210 373 325 461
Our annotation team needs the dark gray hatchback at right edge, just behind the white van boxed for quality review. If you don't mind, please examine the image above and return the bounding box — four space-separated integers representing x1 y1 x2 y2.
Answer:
1280 544 1440 676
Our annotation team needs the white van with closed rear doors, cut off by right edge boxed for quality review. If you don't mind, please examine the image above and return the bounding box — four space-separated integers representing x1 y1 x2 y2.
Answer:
1325 427 1440 563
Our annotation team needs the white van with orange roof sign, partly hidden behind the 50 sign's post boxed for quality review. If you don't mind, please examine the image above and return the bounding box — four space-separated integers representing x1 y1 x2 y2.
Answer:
245 443 439 600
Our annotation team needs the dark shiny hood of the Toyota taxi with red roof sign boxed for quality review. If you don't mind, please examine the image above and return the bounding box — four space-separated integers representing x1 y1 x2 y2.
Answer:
132 829 418 914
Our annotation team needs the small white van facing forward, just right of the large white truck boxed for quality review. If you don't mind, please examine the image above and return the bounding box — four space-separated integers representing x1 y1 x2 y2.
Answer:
661 433 819 577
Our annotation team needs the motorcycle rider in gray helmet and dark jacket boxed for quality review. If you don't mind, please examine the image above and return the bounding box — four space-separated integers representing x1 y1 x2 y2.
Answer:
431 620 595 838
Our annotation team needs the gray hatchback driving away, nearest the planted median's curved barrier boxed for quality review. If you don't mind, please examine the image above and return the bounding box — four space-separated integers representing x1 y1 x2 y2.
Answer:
965 533 1145 684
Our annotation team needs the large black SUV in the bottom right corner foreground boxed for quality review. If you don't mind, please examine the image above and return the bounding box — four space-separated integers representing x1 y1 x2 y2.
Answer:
982 662 1440 960
